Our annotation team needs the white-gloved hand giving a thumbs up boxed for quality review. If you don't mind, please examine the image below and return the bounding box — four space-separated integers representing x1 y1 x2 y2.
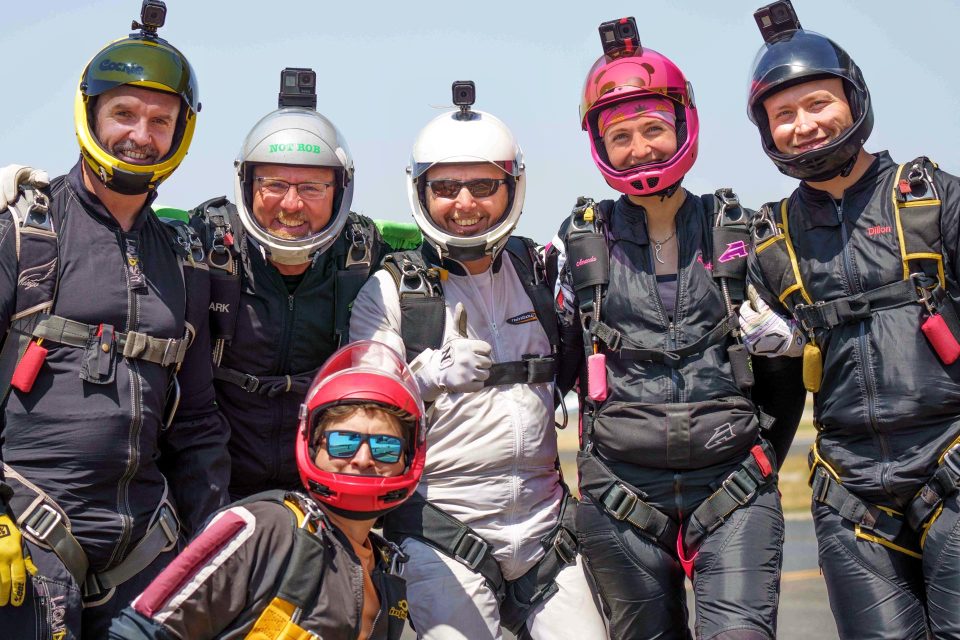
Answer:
411 302 493 402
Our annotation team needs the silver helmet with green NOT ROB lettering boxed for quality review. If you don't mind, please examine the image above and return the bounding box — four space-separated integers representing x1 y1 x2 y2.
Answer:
234 107 353 264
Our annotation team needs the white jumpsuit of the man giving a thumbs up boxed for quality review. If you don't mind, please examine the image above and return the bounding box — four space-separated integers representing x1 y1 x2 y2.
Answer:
350 252 607 640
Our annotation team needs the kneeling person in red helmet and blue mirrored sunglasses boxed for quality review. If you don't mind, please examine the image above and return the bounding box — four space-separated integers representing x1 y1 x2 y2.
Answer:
110 341 425 640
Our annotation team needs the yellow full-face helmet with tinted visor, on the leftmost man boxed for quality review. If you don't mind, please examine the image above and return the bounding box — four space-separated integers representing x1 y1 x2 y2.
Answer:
73 32 200 194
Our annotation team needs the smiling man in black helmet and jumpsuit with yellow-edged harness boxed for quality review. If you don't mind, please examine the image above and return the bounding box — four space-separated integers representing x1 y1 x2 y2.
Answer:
741 2 960 639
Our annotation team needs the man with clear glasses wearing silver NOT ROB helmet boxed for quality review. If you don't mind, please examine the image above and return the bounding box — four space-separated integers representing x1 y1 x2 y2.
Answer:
191 69 384 499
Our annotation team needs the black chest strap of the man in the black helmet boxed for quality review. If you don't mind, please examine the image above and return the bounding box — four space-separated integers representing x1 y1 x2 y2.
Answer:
793 279 928 331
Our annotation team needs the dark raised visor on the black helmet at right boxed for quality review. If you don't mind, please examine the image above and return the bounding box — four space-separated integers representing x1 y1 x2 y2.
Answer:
748 30 863 107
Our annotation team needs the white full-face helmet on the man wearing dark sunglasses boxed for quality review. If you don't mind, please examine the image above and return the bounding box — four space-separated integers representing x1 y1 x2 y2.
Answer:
407 85 526 262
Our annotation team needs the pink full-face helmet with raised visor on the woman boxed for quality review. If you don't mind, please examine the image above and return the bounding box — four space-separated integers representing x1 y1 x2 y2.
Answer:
580 44 700 196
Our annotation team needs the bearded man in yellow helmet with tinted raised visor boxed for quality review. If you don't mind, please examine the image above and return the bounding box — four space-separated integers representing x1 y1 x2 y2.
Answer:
0 10 229 639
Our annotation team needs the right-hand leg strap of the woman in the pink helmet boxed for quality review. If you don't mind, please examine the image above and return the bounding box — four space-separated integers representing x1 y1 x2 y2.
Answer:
683 440 777 550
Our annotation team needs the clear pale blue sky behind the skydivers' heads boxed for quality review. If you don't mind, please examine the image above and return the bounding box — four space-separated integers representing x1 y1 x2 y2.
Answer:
0 0 960 242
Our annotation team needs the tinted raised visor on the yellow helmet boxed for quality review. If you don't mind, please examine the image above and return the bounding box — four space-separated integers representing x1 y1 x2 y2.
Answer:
83 40 199 111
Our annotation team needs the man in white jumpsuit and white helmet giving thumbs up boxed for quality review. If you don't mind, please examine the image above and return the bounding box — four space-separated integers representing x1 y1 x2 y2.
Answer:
350 83 606 640
